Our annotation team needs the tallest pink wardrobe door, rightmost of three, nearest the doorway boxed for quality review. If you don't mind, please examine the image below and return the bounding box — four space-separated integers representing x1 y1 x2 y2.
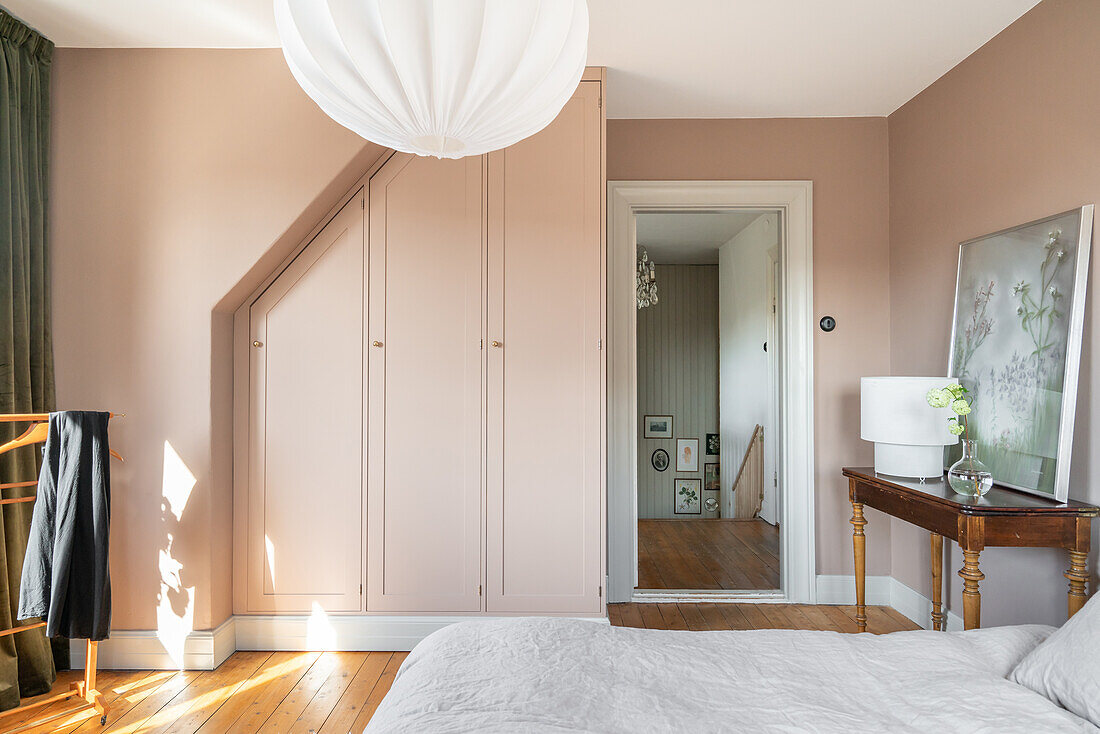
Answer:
486 83 604 613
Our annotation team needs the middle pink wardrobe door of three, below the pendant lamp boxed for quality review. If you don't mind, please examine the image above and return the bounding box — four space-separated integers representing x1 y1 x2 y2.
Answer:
366 153 485 612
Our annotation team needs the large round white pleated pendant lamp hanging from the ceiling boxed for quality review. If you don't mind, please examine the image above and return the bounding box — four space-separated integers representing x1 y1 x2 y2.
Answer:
275 0 589 158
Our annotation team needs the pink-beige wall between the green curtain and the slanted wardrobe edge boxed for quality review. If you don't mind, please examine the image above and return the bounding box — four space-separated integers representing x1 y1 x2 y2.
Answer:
51 48 380 634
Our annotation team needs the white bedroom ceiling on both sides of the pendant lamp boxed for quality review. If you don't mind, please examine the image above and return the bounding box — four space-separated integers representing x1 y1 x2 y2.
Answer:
10 0 1038 118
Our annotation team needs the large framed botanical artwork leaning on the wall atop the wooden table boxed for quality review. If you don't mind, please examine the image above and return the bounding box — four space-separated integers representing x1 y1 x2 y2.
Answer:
945 205 1092 502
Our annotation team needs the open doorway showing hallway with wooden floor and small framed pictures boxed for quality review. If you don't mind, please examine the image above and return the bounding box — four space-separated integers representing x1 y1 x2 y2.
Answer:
636 209 781 592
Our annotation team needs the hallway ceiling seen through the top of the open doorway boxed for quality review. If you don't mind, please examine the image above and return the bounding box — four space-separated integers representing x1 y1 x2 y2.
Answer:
637 209 765 265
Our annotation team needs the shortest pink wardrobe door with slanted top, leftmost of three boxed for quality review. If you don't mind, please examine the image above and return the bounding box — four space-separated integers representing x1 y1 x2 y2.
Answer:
246 191 365 612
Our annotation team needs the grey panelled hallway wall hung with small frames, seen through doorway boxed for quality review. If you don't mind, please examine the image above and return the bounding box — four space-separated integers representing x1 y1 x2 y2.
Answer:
638 265 718 519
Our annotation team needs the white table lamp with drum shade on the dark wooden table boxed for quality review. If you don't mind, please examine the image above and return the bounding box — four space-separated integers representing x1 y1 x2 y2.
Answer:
859 377 958 479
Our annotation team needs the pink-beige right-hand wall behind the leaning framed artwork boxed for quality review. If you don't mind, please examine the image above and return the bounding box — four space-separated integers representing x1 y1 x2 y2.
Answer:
888 0 1100 625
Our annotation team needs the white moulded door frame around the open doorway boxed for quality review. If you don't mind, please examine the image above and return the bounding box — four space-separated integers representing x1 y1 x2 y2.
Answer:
607 180 817 604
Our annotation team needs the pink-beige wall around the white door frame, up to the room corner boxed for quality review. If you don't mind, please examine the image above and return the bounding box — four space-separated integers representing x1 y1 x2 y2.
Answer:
607 117 891 574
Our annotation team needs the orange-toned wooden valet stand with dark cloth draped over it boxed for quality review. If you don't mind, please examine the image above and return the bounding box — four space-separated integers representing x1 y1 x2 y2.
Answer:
0 413 124 734
